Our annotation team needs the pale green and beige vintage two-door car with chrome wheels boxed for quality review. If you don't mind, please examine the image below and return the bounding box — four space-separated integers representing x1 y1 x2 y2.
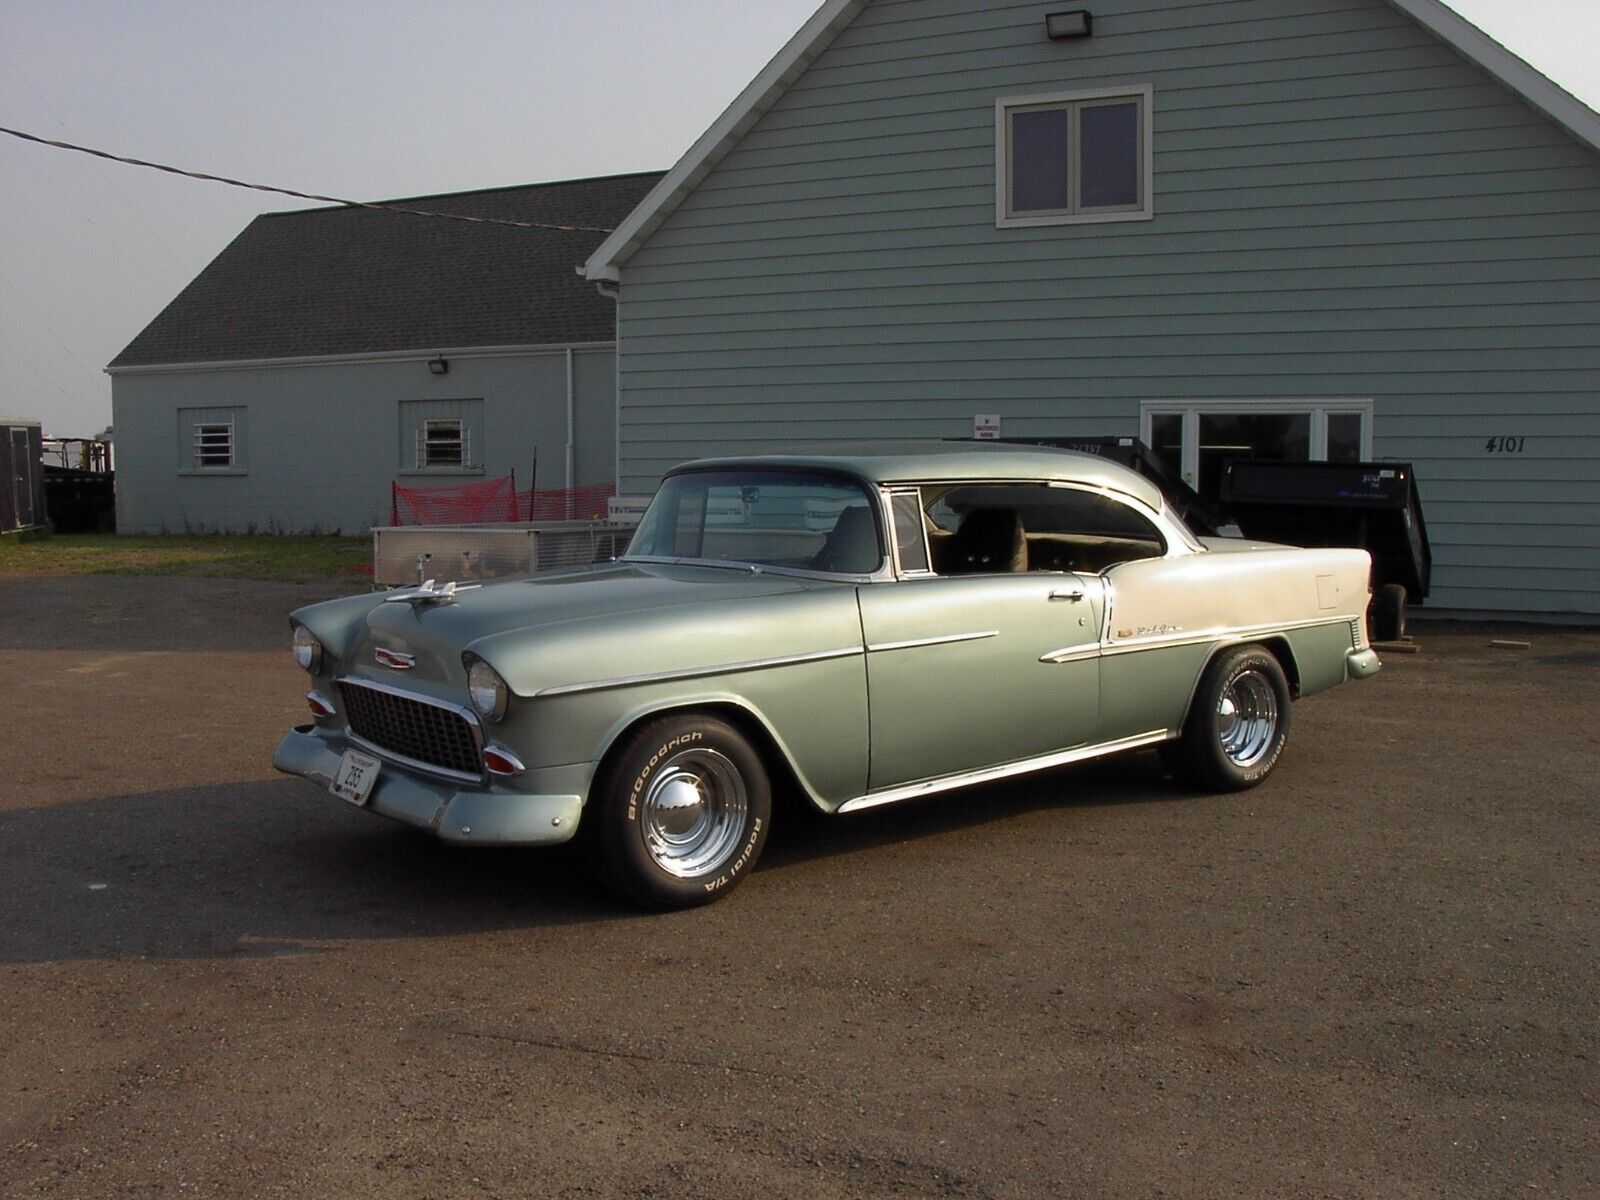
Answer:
274 443 1378 907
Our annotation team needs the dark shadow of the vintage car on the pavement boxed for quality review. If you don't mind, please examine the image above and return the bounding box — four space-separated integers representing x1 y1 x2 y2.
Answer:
0 755 1178 965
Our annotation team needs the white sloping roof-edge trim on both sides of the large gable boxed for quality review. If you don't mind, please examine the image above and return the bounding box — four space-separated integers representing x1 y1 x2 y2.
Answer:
581 0 1600 283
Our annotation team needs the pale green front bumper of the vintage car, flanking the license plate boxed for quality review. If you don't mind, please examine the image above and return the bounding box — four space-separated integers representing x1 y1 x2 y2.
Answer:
272 725 594 846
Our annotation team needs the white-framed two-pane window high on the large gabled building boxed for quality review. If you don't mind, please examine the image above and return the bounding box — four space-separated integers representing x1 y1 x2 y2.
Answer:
995 88 1154 227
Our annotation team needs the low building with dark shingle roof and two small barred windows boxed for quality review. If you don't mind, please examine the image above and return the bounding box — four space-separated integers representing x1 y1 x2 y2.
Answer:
107 173 661 533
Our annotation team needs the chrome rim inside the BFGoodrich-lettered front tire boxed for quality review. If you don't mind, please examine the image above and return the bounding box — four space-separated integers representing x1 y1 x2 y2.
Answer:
638 747 750 878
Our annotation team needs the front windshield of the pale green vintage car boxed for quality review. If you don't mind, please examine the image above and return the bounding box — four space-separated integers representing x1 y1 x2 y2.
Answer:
627 470 883 574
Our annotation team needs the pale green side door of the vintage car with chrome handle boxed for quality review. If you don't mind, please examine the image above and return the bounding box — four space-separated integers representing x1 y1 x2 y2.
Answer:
858 571 1104 790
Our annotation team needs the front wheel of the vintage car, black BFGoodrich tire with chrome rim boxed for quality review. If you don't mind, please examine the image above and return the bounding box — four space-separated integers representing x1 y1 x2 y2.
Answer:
584 714 773 909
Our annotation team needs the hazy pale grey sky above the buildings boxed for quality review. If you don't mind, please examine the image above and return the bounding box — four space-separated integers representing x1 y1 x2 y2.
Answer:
0 0 1600 437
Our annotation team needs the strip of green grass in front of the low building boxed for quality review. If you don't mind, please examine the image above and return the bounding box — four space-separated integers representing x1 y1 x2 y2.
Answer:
0 533 373 581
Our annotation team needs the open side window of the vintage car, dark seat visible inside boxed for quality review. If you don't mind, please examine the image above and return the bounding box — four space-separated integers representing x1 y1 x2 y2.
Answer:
925 483 1166 574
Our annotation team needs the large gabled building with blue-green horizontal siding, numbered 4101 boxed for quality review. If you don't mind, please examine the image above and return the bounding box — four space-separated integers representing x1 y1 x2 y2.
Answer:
586 0 1600 614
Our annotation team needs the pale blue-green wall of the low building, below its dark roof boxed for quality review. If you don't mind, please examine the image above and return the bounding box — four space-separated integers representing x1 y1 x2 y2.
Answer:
112 349 616 533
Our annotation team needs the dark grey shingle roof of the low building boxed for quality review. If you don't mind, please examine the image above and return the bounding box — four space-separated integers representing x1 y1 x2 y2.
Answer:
110 171 661 366
